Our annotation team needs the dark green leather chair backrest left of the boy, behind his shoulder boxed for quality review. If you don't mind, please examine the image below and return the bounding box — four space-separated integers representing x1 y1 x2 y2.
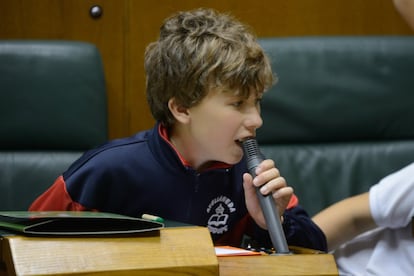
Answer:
0 40 108 210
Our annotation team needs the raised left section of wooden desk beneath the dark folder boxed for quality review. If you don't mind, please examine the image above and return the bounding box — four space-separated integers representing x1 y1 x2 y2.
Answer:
0 227 218 275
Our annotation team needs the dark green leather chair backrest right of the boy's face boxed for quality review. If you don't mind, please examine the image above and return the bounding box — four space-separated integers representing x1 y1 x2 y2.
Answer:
258 36 414 215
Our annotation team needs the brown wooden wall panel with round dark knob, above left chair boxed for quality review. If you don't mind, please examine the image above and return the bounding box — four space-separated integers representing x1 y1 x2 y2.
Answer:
0 0 126 137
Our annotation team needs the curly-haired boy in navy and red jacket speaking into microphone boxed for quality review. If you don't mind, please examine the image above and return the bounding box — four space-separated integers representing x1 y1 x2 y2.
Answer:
30 9 326 250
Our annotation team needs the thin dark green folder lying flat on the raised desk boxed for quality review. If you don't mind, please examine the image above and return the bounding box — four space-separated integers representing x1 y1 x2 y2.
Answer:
0 211 164 236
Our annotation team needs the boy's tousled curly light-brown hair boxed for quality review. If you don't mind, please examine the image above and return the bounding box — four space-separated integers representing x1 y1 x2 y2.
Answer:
145 9 275 127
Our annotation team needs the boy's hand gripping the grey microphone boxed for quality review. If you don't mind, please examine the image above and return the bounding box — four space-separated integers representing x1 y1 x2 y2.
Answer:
243 159 293 229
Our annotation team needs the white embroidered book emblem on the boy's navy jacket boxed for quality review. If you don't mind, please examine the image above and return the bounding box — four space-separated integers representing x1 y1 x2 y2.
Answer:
207 196 236 234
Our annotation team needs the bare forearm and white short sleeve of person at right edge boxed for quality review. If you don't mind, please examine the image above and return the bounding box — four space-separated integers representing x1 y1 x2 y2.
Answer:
313 163 414 250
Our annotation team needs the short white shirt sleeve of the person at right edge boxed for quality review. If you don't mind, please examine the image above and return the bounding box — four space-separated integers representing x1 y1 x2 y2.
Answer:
369 163 414 228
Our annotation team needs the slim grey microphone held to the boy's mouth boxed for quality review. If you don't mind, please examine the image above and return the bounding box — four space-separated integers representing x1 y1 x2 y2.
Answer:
243 138 290 254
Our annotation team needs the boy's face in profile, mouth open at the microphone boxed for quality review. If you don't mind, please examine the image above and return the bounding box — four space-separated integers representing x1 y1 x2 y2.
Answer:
181 88 263 168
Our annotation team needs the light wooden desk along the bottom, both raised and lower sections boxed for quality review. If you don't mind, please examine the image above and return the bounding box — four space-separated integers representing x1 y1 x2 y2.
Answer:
0 227 338 276
